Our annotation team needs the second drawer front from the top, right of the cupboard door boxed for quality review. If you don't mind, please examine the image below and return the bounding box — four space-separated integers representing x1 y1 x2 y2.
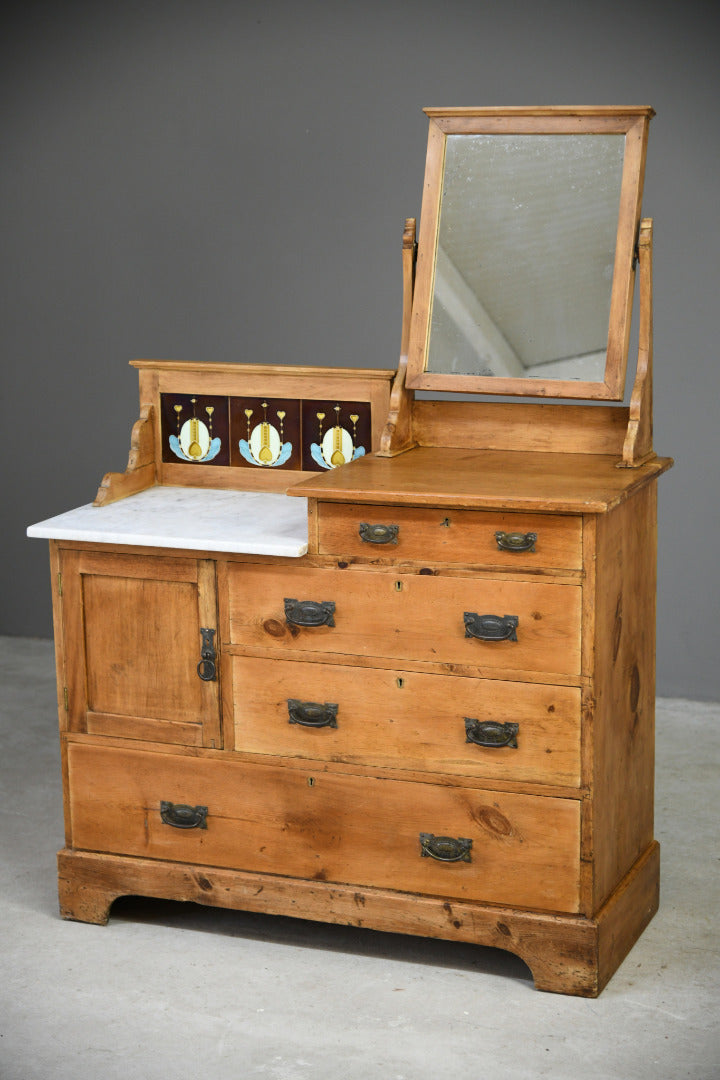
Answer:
228 564 581 675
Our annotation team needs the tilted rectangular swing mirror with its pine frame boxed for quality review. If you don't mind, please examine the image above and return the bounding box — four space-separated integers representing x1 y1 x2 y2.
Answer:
407 108 653 401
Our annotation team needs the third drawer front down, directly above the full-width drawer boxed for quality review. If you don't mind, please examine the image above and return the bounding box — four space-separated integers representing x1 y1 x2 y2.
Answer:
231 657 581 786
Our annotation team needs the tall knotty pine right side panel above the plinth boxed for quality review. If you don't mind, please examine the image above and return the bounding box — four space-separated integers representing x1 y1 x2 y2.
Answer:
593 484 656 910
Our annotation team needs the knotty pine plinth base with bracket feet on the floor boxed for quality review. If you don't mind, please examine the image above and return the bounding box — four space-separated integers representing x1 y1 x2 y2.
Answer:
58 843 660 997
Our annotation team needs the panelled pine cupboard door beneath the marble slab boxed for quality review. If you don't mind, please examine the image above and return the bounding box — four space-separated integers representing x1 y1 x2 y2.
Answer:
63 551 221 747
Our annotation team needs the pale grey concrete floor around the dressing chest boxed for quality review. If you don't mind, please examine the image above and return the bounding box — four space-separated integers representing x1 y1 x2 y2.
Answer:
0 638 720 1080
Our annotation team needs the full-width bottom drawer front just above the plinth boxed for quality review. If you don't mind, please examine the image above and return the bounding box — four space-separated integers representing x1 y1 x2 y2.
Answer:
68 744 580 912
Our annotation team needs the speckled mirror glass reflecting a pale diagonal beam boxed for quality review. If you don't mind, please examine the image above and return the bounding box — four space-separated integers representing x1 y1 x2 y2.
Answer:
426 134 625 382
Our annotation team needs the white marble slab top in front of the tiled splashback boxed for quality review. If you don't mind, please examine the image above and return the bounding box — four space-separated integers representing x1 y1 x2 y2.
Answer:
27 486 308 557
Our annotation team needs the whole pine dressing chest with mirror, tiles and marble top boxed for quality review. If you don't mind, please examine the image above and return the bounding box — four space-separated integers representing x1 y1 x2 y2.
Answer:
29 108 671 996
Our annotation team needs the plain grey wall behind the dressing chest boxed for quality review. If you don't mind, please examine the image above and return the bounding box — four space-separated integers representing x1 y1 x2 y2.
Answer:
0 0 720 699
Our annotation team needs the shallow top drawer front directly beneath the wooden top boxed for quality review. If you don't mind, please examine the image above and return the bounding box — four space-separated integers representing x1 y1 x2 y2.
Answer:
318 502 583 570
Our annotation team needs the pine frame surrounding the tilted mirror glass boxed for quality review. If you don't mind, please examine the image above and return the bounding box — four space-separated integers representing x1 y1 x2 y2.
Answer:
406 106 654 401
